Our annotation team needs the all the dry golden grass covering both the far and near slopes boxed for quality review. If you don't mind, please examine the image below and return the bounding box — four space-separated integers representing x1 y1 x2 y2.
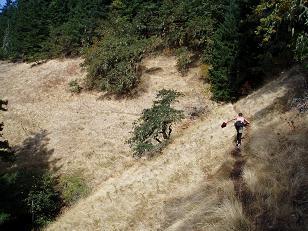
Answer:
0 56 308 231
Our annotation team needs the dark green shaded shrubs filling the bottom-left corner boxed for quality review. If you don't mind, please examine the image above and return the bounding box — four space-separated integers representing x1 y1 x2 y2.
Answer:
0 170 61 230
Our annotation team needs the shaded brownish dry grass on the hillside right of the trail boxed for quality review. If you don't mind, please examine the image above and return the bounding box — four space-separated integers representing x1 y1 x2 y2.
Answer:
237 69 308 230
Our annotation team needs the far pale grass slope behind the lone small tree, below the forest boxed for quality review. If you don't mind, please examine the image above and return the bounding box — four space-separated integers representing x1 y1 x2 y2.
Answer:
0 56 207 188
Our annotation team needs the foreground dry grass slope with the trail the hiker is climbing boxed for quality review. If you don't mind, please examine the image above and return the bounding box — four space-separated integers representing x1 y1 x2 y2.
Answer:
48 64 308 230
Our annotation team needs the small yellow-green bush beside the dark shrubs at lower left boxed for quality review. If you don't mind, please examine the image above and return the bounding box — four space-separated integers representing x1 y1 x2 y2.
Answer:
60 173 90 206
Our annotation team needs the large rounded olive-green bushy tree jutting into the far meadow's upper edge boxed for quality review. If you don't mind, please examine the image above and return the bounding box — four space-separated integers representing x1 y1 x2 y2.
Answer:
85 34 151 94
